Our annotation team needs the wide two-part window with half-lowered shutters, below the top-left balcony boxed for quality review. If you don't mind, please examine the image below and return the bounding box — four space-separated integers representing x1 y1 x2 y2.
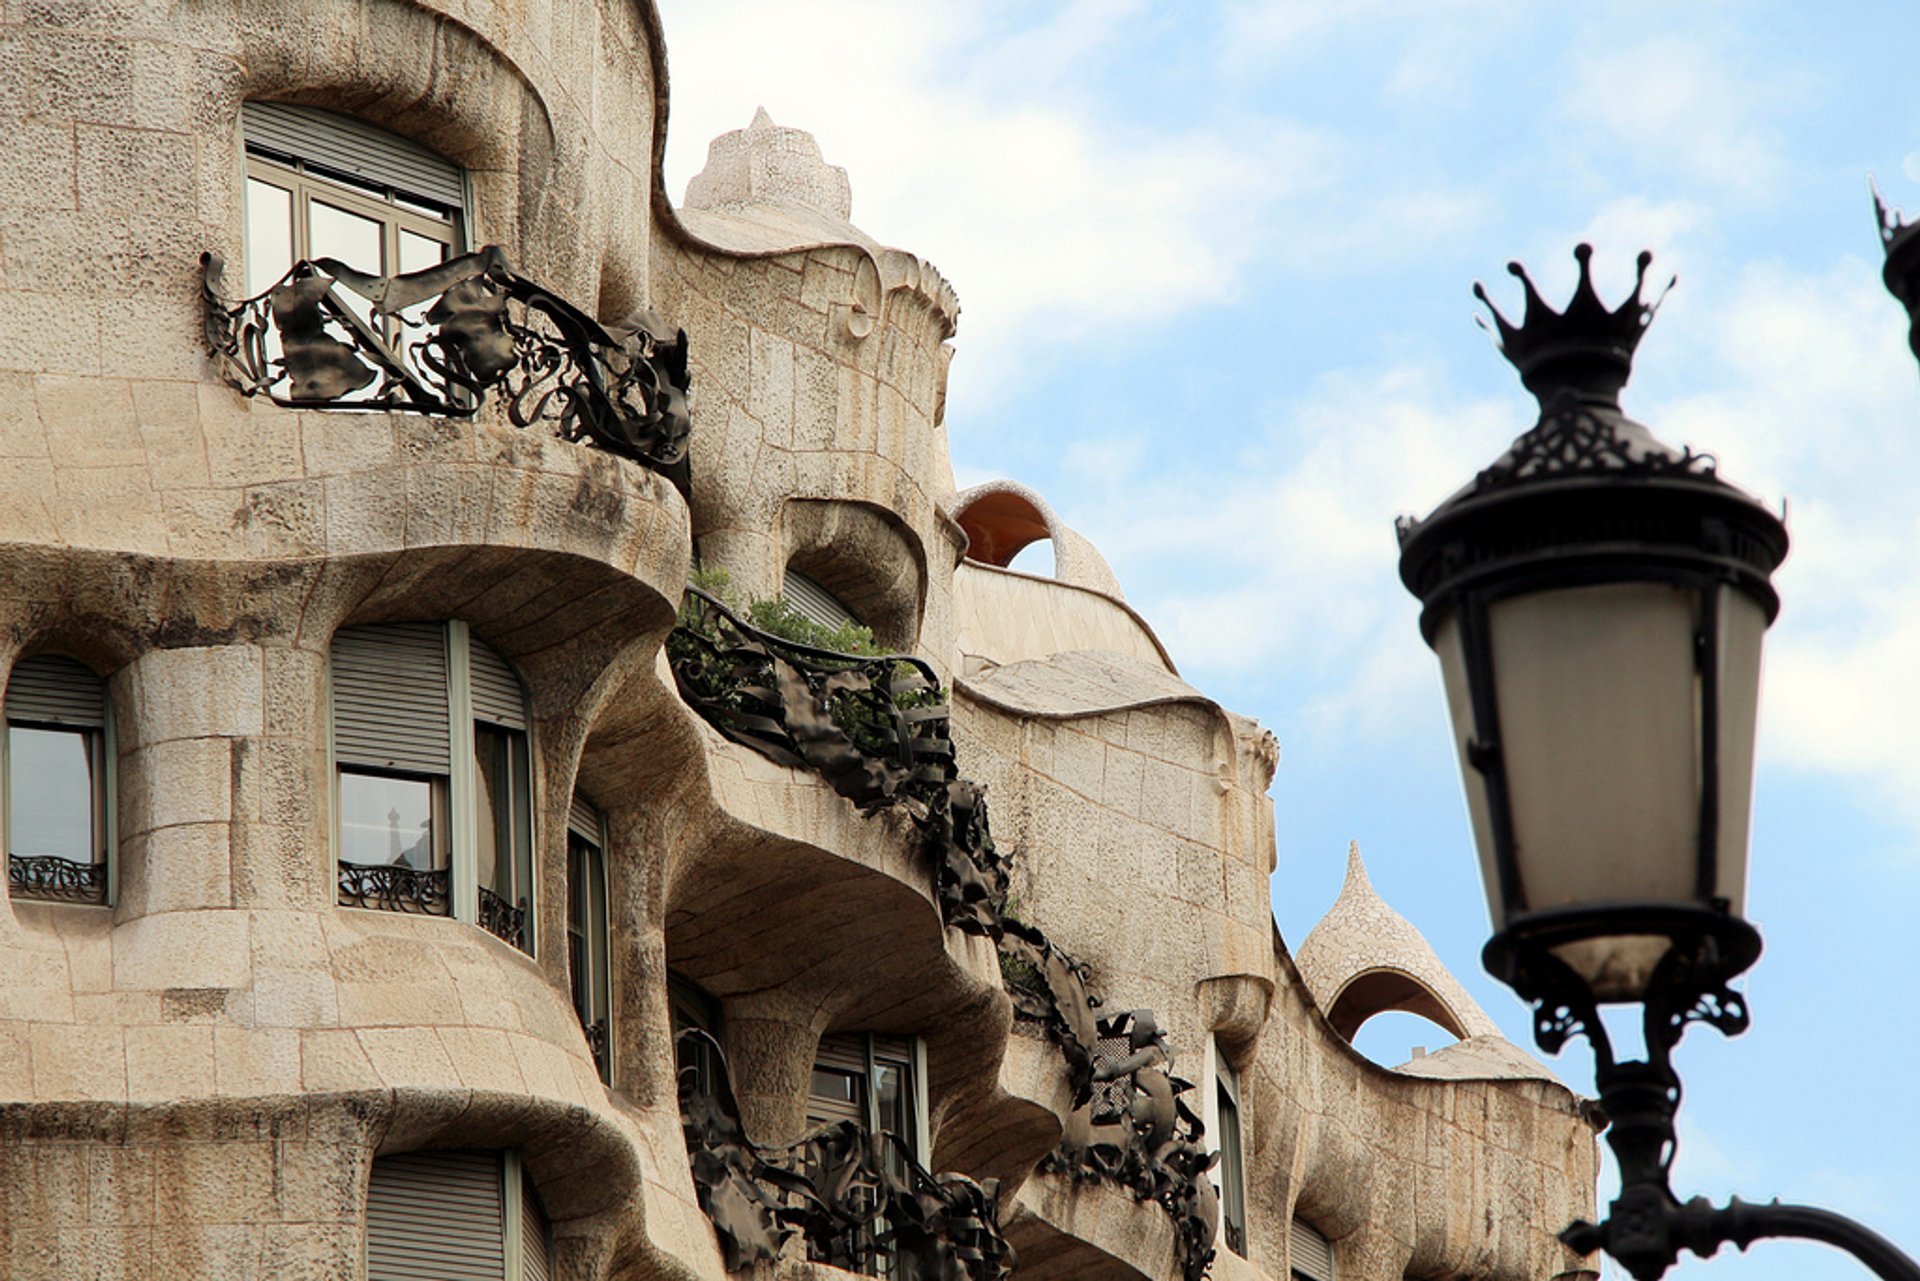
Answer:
330 622 534 953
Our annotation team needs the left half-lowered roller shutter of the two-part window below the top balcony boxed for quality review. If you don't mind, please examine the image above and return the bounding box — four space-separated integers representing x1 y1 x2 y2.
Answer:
332 622 451 774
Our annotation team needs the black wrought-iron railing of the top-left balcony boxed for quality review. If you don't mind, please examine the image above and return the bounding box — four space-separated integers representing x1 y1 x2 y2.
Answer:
200 246 691 490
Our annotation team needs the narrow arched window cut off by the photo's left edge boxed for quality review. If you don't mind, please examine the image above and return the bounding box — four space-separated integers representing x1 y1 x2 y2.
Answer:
4 655 109 903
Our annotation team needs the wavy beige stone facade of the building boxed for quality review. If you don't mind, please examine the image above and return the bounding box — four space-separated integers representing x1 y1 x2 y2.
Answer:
0 0 1594 1281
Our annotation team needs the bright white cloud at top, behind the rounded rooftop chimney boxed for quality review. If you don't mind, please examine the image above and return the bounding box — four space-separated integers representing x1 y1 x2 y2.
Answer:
662 0 1327 394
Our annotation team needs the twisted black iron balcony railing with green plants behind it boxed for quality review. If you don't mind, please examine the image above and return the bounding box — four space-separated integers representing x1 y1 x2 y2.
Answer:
666 588 1008 935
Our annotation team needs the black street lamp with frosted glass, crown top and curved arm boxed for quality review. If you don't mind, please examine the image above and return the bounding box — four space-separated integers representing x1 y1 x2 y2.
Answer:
1400 244 1920 1281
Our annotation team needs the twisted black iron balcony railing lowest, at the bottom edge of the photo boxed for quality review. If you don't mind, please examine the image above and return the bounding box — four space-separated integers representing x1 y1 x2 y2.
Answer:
680 1029 1016 1281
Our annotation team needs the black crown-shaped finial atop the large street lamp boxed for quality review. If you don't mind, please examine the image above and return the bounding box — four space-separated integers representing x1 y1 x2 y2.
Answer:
1473 244 1678 409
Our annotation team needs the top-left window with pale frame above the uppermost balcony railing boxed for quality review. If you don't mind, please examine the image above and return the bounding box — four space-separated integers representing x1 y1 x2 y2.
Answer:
240 102 467 294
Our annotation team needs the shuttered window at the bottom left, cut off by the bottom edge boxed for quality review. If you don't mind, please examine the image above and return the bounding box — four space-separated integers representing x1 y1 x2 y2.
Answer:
367 1152 553 1281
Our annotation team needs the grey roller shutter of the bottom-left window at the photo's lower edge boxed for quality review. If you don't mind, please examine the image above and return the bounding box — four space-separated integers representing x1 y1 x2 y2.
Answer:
367 1152 507 1281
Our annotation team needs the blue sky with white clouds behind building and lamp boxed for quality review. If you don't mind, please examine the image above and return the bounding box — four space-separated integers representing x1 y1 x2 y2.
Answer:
660 0 1920 1281
